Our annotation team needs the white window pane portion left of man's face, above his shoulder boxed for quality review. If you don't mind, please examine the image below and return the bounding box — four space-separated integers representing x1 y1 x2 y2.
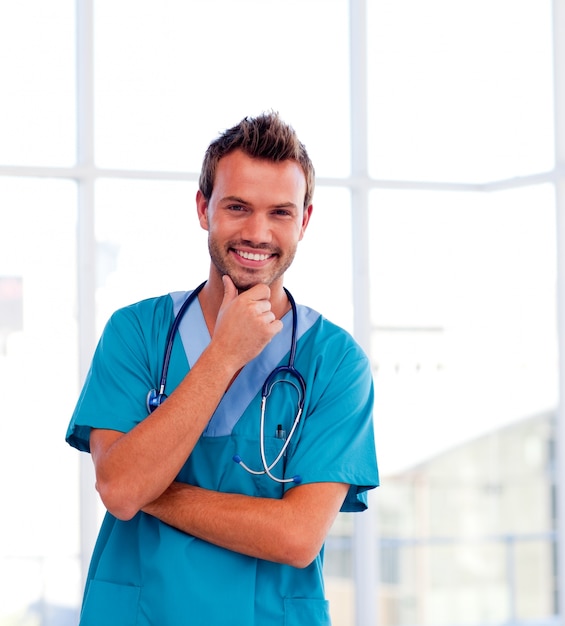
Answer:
95 180 205 322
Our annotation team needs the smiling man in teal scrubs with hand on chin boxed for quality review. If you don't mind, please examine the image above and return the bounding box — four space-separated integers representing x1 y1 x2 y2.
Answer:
67 114 378 626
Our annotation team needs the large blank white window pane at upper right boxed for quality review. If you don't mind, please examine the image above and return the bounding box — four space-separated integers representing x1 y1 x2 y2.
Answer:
367 0 553 181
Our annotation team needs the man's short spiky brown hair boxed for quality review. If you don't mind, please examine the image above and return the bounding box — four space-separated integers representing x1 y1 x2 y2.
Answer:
199 112 315 208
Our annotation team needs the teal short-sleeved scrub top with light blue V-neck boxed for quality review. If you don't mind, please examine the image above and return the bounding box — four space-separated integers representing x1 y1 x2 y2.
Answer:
67 292 379 626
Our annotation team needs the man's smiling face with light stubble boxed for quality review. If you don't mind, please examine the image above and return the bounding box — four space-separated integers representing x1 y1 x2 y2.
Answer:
197 150 312 291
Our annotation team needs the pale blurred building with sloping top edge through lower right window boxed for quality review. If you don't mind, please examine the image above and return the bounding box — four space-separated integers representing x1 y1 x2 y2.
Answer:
378 414 557 626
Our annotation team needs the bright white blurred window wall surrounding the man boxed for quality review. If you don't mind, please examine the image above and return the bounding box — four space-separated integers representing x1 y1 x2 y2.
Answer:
0 0 565 626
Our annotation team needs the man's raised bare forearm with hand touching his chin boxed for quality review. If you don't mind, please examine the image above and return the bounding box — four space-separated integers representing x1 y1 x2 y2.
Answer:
90 277 282 520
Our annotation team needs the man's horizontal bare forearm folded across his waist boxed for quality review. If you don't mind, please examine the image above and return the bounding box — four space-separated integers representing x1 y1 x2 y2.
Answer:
143 482 348 567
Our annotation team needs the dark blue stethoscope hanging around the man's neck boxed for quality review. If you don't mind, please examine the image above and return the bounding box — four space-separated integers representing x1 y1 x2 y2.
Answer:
147 281 306 484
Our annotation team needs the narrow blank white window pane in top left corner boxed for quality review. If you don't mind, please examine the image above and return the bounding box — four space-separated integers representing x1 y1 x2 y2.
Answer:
0 0 76 166
